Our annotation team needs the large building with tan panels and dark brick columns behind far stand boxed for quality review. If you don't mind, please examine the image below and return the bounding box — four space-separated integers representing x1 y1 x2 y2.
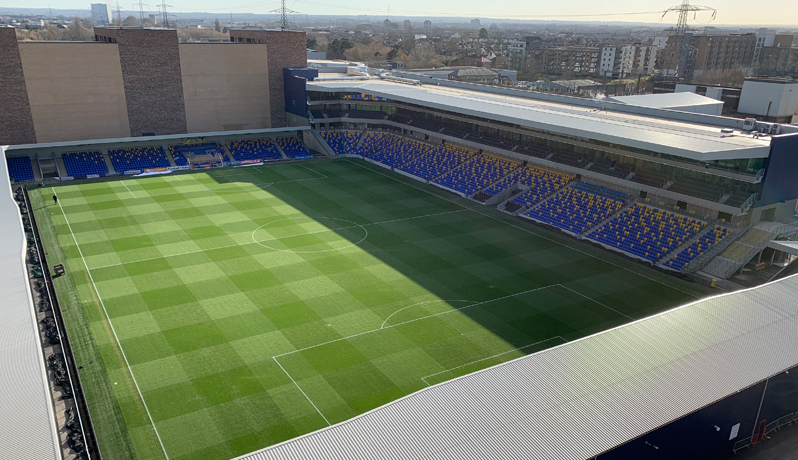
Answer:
0 27 307 145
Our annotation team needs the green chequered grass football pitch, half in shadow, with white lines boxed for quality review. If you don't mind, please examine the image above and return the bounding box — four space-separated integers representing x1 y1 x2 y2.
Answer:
31 160 707 460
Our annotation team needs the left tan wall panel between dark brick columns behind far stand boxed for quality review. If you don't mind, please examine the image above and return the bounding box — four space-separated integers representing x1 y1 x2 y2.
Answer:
19 42 130 142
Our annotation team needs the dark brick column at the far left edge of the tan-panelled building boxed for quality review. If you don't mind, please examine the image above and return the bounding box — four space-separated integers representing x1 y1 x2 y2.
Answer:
0 27 36 145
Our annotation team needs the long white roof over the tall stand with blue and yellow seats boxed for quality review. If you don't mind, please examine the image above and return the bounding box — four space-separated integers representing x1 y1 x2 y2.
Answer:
307 80 770 161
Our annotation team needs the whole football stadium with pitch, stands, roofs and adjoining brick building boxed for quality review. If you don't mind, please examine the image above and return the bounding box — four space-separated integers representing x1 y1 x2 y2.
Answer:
0 27 798 460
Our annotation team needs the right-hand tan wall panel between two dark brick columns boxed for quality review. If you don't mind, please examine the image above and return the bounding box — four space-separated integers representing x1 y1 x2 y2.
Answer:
178 43 271 133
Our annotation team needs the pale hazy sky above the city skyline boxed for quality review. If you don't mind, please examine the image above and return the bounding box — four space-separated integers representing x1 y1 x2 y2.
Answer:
9 0 798 26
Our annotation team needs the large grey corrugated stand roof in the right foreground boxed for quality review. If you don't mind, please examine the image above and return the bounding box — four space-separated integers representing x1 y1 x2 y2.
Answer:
240 275 798 460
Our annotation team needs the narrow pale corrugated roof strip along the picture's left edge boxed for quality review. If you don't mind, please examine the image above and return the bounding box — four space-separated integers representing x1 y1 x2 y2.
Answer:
0 147 61 460
